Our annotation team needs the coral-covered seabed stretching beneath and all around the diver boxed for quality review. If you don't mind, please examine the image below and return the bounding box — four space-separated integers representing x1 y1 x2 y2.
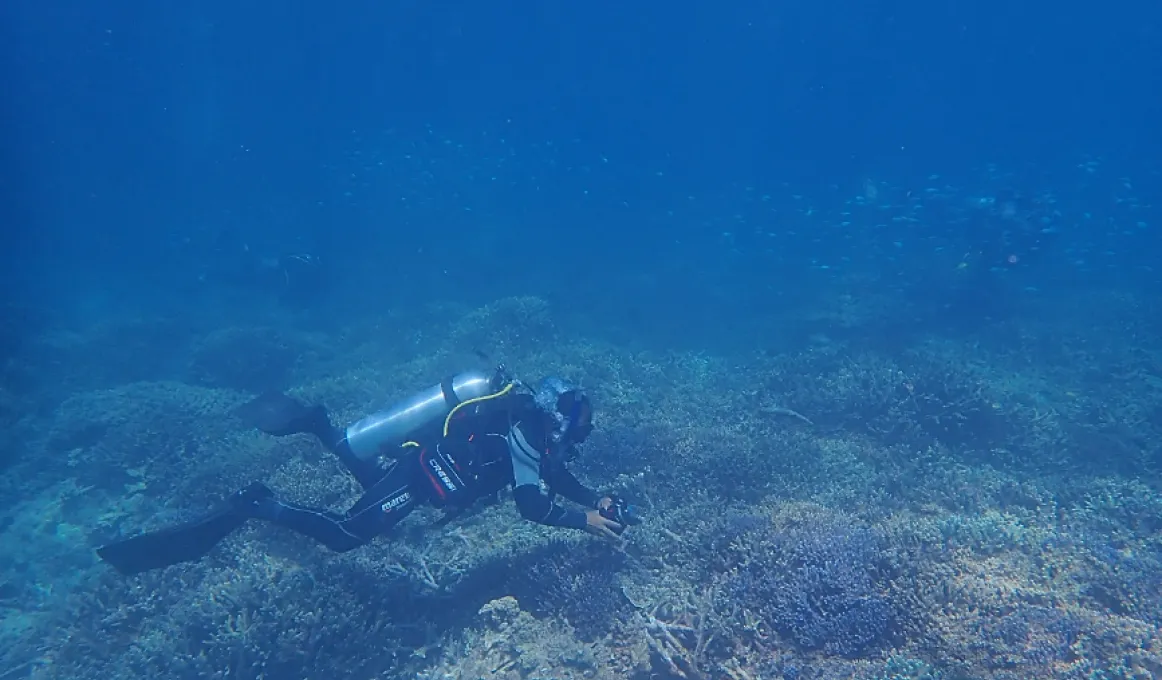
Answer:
0 291 1162 680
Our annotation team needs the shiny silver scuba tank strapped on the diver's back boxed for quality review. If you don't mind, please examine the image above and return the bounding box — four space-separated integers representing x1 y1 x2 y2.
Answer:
346 371 496 460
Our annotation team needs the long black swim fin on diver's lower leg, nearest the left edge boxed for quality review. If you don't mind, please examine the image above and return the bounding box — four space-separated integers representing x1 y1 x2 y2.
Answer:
96 508 246 574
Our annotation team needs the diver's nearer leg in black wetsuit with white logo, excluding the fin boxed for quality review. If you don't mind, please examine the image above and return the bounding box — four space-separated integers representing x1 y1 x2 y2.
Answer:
235 459 426 552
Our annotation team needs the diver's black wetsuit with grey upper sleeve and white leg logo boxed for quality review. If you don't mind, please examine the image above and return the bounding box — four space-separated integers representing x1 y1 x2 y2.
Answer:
234 398 600 552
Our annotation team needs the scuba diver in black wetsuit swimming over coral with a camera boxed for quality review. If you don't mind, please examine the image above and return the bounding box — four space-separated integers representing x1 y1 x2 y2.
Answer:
96 366 640 574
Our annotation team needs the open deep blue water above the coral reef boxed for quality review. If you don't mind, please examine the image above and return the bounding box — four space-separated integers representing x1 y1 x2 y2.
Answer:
0 0 1162 679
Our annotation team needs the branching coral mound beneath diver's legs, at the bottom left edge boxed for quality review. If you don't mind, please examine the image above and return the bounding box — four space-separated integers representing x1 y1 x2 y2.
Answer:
36 549 428 679
